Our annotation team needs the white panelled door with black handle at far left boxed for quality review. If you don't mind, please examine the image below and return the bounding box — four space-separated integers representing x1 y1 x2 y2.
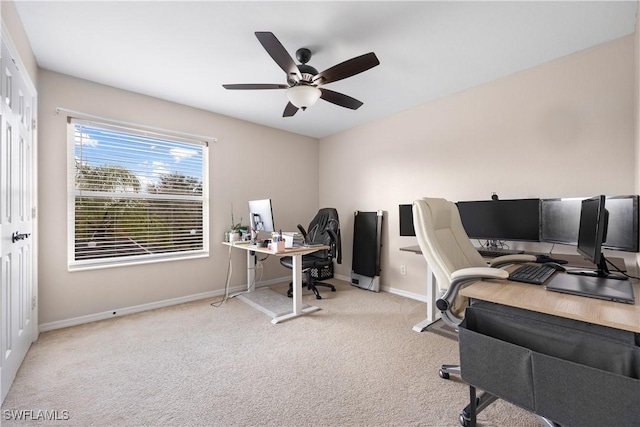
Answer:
0 32 37 401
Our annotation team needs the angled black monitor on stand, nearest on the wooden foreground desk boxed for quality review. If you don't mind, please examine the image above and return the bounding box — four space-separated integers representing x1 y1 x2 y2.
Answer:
568 195 626 280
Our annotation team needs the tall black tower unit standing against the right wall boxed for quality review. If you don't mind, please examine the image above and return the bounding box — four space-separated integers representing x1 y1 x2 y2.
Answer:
351 211 383 292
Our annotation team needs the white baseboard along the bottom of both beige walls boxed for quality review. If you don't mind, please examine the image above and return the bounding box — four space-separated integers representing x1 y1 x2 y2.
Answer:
38 275 427 332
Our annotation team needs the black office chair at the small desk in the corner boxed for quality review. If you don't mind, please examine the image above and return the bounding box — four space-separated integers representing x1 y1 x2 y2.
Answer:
280 208 342 299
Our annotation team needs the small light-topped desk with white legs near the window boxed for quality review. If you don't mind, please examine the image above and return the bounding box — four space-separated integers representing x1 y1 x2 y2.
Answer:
222 242 330 324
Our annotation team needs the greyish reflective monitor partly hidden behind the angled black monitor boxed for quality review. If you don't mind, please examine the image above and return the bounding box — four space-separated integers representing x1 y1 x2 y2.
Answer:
540 195 640 252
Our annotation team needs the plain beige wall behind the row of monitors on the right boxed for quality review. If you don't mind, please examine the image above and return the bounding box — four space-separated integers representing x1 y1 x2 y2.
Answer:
320 36 637 296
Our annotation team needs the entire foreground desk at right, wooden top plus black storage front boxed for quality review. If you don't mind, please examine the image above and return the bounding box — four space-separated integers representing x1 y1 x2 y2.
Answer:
459 266 640 426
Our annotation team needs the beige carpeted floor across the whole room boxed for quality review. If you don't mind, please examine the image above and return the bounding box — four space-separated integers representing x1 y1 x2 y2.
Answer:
2 280 538 427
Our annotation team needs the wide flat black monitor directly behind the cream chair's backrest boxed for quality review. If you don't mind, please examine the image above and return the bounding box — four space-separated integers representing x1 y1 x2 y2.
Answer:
457 199 540 242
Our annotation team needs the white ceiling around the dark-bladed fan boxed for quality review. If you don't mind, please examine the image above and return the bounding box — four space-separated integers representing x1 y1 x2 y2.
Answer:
15 0 638 138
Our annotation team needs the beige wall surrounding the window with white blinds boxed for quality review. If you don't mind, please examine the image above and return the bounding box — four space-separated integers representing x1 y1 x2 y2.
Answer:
38 70 319 325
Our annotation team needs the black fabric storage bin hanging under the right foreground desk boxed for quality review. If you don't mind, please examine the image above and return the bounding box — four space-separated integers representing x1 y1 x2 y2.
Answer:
459 301 640 427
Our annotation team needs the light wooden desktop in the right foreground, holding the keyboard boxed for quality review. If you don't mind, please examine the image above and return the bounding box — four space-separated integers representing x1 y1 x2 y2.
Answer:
460 267 640 333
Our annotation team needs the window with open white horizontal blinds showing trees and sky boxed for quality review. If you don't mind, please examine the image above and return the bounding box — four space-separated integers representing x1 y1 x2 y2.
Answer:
67 119 209 269
